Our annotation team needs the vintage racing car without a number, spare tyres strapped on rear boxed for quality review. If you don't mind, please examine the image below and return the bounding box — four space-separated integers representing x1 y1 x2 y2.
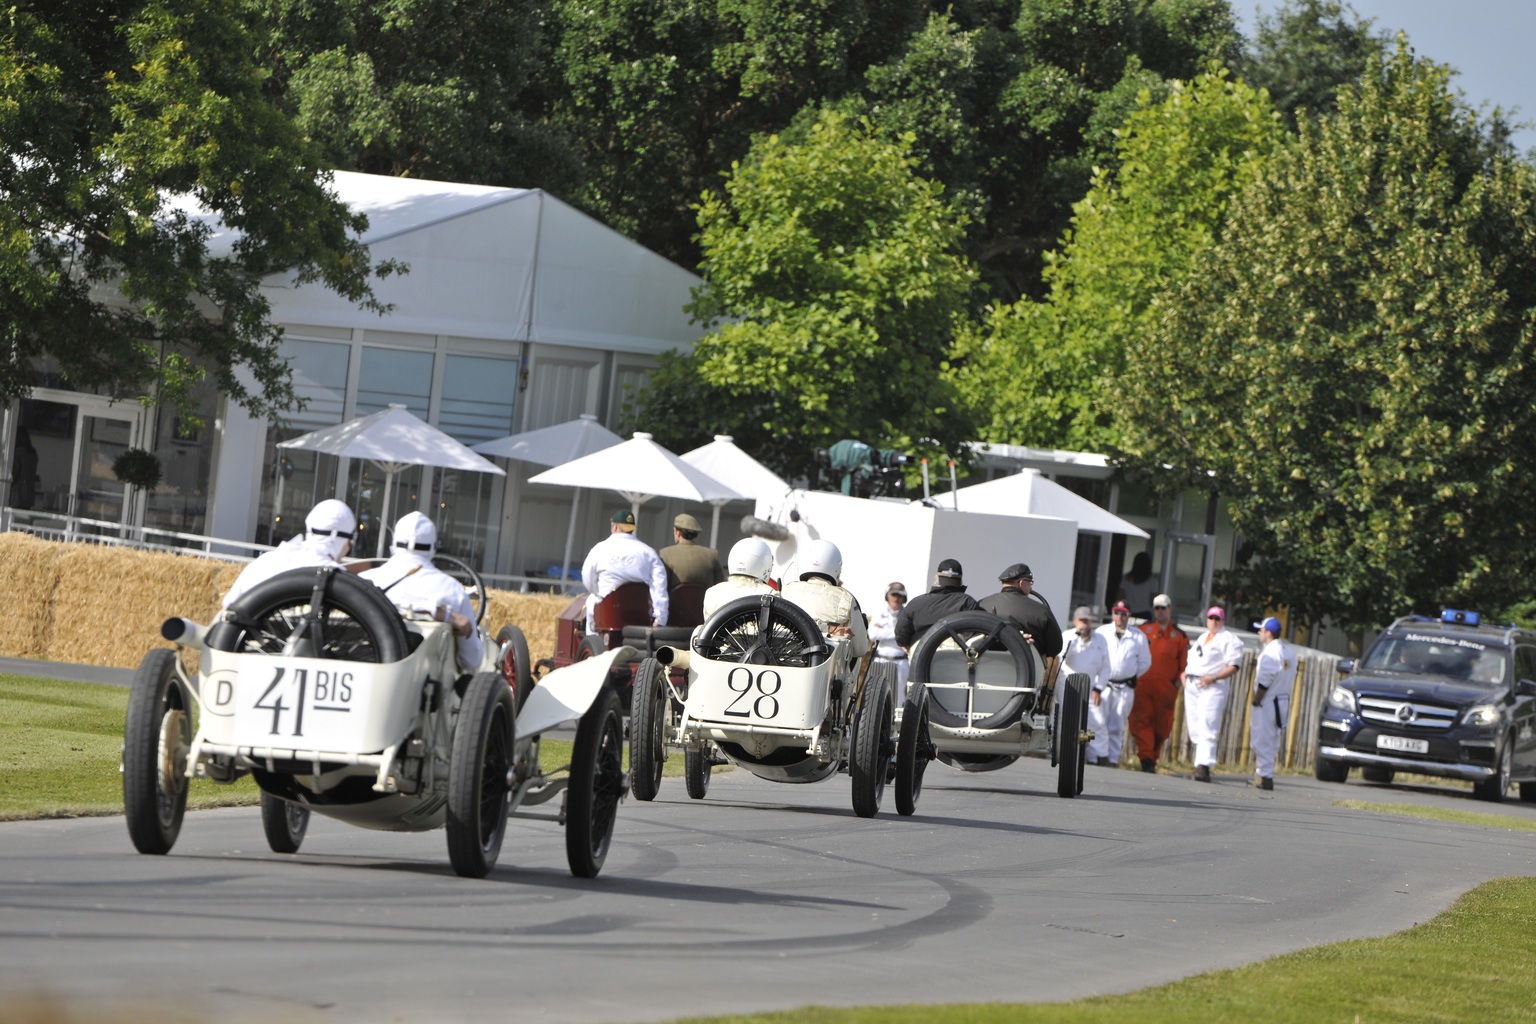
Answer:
902 611 1094 797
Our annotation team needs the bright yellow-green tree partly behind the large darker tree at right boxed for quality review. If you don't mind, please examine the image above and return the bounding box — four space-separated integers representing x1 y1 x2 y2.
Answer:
957 71 1283 451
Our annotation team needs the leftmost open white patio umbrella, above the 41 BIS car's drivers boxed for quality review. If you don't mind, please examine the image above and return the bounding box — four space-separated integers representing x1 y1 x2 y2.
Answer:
278 405 507 557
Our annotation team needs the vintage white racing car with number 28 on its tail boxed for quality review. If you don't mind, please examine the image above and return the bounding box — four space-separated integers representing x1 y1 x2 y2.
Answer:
630 594 915 818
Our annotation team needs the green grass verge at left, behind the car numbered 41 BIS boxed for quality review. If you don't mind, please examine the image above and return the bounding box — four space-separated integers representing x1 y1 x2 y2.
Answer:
0 674 685 821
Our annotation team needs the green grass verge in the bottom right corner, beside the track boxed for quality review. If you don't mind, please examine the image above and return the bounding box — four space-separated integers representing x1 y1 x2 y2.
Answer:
679 878 1536 1024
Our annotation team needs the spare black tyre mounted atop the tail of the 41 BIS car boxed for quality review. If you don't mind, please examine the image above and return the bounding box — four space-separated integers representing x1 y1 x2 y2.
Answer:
204 568 409 665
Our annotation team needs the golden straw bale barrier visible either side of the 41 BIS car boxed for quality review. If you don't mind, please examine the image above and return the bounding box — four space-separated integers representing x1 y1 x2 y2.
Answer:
0 531 570 668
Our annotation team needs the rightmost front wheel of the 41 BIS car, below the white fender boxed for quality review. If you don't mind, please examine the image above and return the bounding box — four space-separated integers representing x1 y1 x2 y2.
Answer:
565 686 624 878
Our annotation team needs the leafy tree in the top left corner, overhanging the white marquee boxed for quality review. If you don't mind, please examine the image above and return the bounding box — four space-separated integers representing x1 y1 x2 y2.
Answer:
0 0 387 416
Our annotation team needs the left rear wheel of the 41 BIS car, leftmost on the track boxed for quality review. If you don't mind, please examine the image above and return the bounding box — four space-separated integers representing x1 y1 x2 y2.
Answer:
123 648 192 854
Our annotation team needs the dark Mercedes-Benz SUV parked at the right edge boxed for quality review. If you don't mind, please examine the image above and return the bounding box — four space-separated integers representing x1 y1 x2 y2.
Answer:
1315 609 1536 801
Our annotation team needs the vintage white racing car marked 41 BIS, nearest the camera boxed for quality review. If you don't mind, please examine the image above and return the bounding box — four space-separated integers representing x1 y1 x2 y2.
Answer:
123 568 634 878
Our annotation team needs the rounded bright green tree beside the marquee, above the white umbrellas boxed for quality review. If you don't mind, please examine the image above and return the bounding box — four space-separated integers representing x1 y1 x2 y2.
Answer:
620 112 975 473
